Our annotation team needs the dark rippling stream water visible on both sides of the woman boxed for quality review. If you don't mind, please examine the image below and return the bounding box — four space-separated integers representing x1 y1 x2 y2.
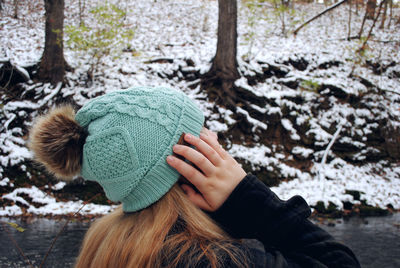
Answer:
0 213 400 268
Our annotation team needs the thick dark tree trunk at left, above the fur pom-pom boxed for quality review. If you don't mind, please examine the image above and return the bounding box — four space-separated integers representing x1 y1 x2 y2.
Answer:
38 0 67 85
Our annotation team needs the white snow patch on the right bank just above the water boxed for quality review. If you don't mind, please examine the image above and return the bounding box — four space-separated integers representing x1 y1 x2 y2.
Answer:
271 160 400 208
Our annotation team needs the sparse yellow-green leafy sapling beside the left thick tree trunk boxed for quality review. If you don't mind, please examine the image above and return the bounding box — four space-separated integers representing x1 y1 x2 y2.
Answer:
65 2 135 77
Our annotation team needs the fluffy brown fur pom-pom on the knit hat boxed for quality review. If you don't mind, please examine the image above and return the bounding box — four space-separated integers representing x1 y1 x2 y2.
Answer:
29 105 87 179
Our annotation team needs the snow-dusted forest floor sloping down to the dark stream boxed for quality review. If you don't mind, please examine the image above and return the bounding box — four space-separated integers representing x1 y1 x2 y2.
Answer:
0 0 400 216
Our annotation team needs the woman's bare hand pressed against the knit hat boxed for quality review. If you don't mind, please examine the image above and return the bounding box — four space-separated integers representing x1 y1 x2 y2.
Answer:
167 128 246 211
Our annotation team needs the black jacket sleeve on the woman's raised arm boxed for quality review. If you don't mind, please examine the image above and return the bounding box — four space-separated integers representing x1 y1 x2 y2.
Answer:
211 174 360 267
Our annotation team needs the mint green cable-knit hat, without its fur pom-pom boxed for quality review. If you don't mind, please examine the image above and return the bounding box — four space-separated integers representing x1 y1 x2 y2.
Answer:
75 87 204 212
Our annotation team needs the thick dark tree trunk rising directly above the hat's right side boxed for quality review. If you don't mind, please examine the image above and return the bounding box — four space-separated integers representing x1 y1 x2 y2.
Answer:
204 0 240 105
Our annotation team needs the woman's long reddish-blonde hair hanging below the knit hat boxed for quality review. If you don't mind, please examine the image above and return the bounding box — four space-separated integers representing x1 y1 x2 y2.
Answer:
76 185 247 268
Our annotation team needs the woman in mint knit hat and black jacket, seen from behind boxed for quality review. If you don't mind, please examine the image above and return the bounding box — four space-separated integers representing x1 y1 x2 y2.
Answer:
30 88 359 268
